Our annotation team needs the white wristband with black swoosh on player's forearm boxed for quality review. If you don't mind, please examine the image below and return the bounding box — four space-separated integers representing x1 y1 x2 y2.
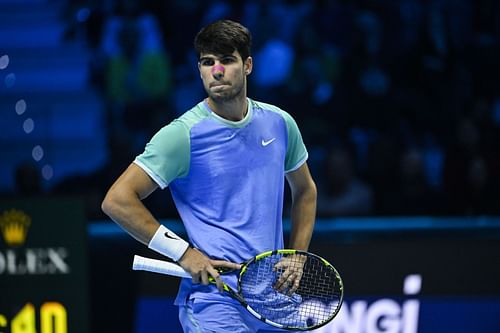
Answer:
148 224 189 261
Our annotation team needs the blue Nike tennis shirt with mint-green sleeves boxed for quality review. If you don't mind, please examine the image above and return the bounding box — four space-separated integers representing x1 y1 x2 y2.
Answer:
134 99 308 304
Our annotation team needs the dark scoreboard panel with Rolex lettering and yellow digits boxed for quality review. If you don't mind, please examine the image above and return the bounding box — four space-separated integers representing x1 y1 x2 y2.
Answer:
0 199 89 333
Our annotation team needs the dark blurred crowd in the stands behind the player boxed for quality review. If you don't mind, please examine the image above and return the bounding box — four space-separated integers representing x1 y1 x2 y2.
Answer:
15 0 500 218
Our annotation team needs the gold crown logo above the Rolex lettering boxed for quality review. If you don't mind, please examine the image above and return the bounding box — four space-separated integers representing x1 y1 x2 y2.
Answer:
0 209 31 246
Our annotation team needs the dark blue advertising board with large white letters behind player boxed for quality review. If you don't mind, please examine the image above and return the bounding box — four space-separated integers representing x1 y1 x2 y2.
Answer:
130 219 500 333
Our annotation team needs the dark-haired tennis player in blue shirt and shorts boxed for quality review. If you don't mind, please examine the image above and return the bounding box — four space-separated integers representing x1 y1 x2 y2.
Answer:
102 20 316 333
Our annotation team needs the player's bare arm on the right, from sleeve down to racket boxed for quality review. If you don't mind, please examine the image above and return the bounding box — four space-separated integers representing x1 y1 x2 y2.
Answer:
286 163 317 251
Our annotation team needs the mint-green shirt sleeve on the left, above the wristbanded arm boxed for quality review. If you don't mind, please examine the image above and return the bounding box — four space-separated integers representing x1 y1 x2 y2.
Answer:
134 120 190 189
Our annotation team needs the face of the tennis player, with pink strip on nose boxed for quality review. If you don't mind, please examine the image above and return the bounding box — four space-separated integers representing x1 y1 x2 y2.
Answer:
198 51 252 103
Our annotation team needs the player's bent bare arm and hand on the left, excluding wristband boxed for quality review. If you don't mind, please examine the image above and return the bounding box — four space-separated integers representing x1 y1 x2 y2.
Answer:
101 164 239 290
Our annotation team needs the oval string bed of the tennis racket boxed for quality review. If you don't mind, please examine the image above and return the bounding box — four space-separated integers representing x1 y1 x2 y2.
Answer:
240 253 341 328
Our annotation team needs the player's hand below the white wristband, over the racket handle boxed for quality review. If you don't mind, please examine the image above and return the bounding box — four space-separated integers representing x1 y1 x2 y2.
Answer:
178 247 241 291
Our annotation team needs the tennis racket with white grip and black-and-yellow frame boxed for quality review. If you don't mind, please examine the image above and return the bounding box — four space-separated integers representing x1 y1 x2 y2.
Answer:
133 250 344 331
